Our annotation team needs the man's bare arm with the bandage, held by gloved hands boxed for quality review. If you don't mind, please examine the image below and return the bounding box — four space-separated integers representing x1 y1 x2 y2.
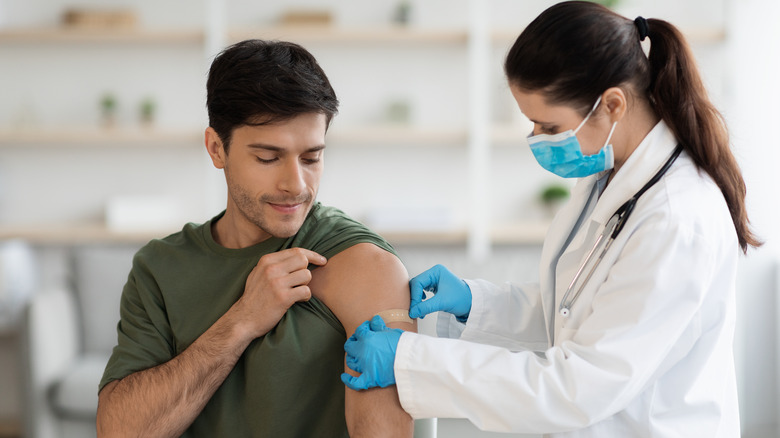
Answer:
310 243 417 438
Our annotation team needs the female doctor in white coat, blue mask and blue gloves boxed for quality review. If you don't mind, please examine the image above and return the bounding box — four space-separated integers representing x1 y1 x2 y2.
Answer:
342 2 760 438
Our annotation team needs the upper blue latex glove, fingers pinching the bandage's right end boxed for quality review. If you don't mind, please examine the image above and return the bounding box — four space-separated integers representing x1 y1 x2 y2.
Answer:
409 265 471 322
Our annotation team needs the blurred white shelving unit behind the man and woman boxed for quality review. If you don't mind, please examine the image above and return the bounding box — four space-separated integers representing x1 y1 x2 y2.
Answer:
0 0 726 252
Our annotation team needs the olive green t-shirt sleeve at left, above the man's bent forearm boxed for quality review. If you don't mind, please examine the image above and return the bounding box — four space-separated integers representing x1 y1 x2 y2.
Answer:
98 250 175 391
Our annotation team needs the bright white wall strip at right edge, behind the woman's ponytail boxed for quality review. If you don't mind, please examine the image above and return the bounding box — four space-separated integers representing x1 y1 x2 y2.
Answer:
723 0 780 437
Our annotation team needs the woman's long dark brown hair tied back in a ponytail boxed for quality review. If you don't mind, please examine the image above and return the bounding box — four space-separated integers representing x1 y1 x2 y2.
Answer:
504 1 761 252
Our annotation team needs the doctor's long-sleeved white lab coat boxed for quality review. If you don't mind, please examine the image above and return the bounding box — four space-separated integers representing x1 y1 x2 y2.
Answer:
395 122 740 438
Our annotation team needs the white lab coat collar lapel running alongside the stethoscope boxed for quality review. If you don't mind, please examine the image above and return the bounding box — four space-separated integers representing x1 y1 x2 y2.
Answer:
591 120 677 224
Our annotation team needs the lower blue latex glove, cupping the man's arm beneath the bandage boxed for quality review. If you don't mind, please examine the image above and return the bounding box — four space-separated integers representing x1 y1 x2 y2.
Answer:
341 315 403 391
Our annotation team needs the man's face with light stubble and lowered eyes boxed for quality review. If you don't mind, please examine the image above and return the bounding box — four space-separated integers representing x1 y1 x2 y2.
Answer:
216 113 326 240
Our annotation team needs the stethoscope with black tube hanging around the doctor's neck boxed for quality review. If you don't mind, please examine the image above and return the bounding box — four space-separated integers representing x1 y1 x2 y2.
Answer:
558 144 683 318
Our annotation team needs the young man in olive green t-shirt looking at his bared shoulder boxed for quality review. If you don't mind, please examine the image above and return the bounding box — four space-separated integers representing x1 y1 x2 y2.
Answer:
97 40 415 437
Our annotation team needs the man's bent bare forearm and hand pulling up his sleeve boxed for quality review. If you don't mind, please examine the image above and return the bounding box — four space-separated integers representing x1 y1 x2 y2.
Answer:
97 249 325 437
